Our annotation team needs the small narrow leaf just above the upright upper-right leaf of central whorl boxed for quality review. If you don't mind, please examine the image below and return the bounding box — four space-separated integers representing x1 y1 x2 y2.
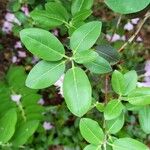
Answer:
71 10 92 24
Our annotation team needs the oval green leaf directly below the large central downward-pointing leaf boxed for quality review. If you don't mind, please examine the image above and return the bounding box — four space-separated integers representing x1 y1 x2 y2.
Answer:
79 118 104 145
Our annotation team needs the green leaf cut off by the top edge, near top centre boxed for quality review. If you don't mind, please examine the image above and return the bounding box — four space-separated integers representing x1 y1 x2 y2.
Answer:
71 0 93 15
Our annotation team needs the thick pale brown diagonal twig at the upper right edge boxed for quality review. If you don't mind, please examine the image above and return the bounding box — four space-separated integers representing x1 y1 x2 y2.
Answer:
118 11 150 52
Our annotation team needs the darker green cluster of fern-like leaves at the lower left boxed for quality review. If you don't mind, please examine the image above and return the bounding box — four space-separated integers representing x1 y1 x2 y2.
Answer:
0 66 44 147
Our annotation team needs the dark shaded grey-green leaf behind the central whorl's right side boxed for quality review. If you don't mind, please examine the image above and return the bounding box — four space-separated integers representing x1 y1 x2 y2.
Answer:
96 44 120 65
